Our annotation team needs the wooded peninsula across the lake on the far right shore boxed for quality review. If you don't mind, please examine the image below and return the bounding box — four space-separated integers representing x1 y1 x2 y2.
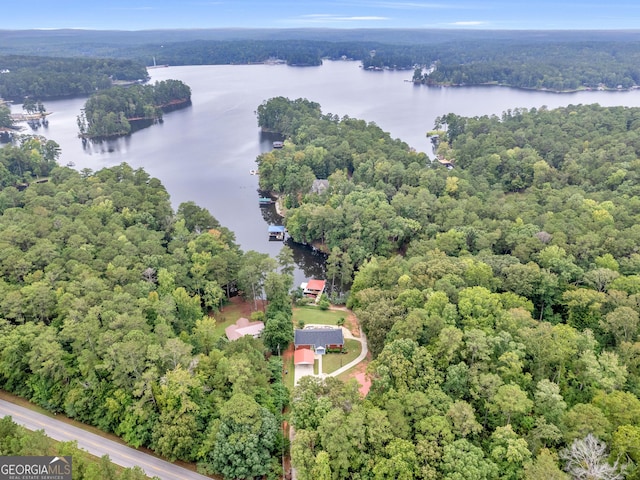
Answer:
414 42 640 91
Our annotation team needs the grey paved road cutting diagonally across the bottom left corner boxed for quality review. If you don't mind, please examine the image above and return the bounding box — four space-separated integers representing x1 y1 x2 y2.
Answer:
0 400 211 480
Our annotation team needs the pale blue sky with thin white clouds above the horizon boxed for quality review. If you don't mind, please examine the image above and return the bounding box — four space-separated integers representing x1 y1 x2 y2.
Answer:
0 0 640 30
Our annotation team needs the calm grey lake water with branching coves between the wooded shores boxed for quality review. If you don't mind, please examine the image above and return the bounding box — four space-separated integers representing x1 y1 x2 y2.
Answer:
13 61 640 284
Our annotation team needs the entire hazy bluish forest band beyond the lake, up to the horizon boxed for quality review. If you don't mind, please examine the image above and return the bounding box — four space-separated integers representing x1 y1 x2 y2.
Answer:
6 29 640 94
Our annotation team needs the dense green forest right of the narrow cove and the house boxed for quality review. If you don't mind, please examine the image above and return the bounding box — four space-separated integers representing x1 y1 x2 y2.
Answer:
258 98 640 480
